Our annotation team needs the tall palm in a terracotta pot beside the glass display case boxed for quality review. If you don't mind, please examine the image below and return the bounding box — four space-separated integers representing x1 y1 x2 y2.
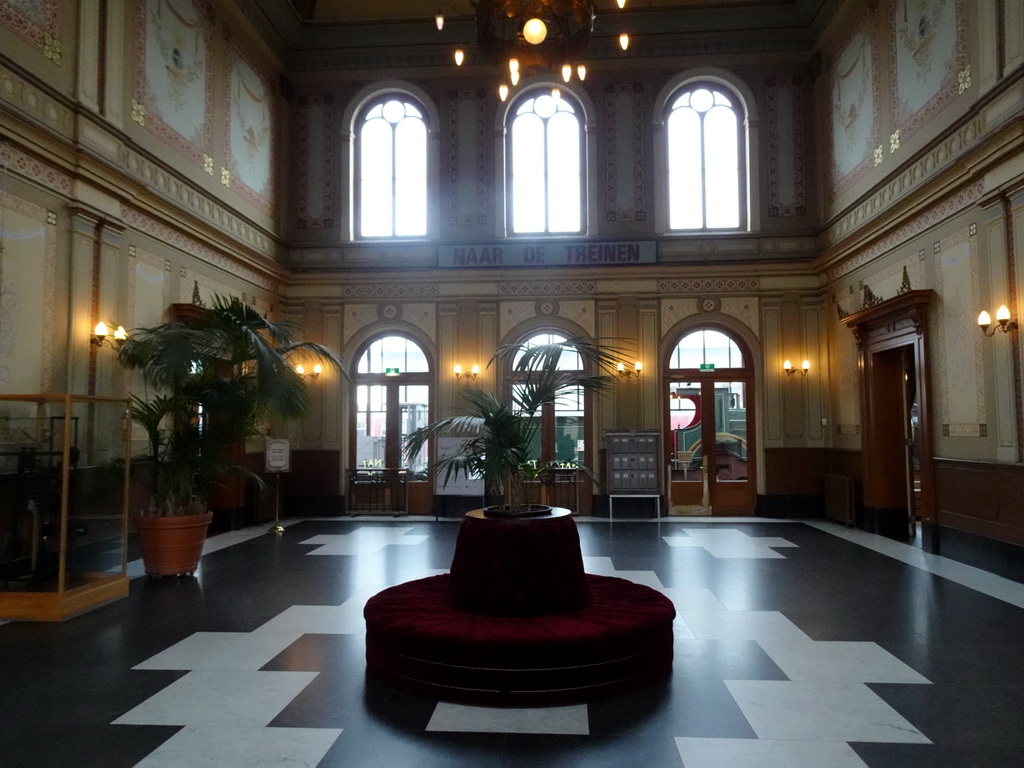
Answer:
118 296 341 575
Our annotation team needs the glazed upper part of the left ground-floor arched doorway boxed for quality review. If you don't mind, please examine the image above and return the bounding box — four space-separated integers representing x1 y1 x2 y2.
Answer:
352 335 431 475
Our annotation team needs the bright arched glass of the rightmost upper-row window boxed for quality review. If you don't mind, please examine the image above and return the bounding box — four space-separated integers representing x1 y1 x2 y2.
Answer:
666 83 745 230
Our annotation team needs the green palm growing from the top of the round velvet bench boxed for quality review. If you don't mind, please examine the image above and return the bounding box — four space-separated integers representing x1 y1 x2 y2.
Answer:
406 337 623 517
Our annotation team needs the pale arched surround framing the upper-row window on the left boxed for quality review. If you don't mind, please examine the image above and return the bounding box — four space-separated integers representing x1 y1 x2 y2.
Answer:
340 80 440 242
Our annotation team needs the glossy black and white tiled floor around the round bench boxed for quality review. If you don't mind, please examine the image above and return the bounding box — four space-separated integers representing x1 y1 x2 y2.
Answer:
0 518 1024 768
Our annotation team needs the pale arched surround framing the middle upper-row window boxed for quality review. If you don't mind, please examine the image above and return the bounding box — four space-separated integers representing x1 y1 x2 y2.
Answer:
495 77 597 239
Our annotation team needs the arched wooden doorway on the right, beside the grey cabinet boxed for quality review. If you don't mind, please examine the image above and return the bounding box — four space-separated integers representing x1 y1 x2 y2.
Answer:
663 328 757 515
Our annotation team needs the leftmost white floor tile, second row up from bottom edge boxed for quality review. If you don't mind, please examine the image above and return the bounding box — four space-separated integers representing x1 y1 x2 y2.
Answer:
114 670 317 726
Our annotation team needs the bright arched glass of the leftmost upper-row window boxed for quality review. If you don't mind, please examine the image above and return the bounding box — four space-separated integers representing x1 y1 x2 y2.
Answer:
356 93 427 238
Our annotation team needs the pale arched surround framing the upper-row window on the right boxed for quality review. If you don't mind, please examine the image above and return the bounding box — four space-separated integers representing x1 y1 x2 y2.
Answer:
653 68 761 236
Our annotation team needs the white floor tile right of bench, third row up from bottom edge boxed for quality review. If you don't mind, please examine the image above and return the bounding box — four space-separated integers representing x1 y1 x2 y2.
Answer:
761 640 931 683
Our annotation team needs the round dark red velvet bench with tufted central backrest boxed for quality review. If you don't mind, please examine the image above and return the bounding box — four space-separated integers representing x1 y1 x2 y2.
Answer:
364 515 676 707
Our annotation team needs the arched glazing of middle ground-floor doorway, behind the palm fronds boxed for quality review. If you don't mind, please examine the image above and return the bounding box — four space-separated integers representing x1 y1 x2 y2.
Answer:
510 332 588 465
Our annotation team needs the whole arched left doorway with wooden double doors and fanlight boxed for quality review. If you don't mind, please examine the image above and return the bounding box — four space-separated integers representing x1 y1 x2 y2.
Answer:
347 334 433 512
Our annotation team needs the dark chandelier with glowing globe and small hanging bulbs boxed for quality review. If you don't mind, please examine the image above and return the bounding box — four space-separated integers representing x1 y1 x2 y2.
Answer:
434 0 629 101
